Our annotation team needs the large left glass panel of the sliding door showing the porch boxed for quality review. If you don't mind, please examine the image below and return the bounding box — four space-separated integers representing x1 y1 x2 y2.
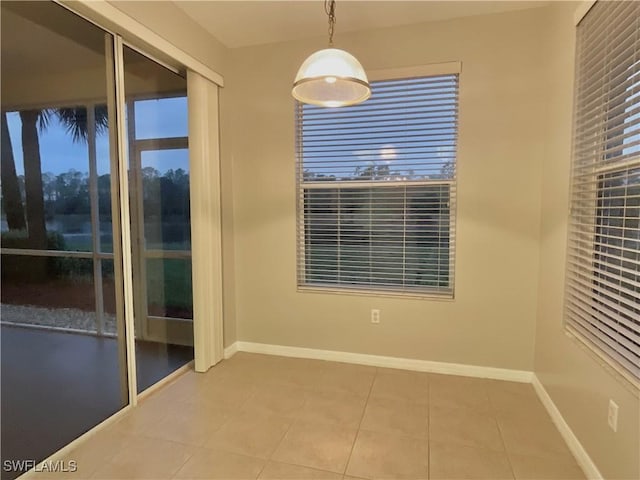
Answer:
0 1 128 479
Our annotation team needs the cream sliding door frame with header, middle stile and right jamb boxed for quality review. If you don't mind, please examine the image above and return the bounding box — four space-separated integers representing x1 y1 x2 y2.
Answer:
53 0 224 382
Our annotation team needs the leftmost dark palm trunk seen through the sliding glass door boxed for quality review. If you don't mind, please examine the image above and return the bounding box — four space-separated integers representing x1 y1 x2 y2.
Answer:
0 112 27 230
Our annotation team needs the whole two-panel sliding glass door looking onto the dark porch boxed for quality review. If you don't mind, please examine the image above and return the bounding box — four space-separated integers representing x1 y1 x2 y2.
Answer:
0 1 193 479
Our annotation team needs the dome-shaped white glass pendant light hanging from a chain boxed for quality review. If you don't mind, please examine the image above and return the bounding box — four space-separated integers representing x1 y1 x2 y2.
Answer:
291 0 371 107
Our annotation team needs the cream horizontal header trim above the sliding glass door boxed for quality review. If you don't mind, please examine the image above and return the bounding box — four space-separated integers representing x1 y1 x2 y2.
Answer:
56 0 224 87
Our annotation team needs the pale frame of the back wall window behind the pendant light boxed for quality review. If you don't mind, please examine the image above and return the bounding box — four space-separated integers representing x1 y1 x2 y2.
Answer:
294 62 462 301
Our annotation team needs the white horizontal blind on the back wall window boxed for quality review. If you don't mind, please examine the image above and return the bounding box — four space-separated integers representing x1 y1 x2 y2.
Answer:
296 74 458 296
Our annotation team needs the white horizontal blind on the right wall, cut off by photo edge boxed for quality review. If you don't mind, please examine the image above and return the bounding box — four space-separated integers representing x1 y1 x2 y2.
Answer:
565 1 640 379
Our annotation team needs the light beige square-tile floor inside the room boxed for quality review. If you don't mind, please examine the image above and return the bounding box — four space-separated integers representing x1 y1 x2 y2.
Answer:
37 353 584 480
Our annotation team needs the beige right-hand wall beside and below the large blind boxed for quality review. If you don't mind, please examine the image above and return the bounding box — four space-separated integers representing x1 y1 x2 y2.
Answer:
535 3 640 479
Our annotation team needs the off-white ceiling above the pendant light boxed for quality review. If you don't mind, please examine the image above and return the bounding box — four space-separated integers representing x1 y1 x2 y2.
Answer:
174 0 550 48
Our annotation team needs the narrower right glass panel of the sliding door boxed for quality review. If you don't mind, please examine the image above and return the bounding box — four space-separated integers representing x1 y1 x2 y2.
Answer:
124 47 193 391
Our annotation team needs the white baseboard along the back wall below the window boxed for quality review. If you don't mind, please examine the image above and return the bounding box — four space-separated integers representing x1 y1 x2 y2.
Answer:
225 342 533 383
